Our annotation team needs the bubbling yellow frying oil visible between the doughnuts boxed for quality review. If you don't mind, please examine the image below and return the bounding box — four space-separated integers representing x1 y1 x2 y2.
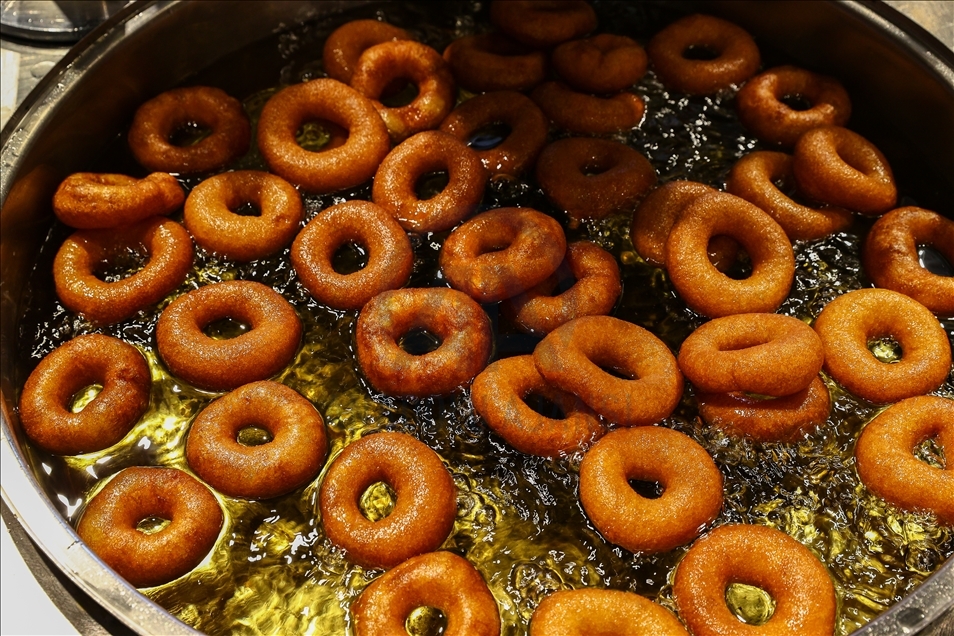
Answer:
14 3 954 636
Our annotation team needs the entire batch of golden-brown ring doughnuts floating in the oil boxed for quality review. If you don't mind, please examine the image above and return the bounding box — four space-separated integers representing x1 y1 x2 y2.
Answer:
19 0 954 636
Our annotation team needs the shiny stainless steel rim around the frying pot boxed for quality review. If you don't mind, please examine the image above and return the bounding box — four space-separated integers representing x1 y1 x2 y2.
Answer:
0 0 954 636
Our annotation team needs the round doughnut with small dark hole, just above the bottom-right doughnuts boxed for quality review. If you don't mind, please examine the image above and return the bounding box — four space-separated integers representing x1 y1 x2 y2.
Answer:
580 426 722 554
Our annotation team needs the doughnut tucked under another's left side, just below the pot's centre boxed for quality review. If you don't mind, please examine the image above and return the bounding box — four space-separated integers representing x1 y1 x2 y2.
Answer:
470 355 606 457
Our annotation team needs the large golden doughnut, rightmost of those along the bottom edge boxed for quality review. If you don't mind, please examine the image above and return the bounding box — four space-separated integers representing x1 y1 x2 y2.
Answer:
673 524 837 636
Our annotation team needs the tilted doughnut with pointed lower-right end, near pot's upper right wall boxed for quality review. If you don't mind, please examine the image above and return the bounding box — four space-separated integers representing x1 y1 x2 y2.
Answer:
792 126 898 216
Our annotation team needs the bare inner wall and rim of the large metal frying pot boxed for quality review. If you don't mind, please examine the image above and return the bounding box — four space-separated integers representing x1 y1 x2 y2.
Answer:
0 0 954 636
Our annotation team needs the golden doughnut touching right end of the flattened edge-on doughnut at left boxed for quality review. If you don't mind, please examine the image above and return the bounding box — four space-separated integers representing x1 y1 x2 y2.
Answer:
184 170 303 262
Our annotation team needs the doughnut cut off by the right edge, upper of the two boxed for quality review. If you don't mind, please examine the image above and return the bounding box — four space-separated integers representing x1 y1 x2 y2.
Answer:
862 207 954 317
